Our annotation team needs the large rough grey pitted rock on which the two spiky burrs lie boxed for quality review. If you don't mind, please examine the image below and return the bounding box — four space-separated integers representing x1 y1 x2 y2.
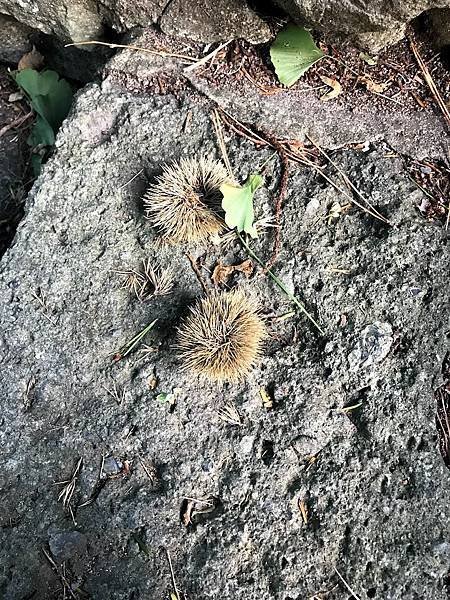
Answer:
0 53 450 600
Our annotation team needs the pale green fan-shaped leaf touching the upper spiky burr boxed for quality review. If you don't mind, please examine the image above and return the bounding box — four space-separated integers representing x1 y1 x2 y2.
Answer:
220 173 263 238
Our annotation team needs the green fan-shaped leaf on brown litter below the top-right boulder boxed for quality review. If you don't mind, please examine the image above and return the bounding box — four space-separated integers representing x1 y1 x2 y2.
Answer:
270 23 325 87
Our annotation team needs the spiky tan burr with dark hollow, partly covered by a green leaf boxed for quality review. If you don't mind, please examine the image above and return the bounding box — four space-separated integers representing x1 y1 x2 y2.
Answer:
144 158 228 243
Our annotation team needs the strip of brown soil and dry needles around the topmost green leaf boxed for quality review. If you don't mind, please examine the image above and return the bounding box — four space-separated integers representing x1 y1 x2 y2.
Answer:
198 30 450 118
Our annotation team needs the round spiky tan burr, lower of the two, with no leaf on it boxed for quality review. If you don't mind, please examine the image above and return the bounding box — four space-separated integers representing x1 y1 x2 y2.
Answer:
178 289 267 382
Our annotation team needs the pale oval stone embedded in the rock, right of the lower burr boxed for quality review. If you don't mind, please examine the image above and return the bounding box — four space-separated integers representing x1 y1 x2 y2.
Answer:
348 321 394 371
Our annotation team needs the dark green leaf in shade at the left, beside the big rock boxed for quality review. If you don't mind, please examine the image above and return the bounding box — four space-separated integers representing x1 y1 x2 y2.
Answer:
16 69 73 133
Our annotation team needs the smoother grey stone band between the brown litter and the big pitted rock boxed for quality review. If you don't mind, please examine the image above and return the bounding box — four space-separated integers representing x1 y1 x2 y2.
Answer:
106 31 449 160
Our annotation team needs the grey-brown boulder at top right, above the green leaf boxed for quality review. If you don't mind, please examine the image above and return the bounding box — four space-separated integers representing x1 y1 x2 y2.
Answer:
276 0 450 52
